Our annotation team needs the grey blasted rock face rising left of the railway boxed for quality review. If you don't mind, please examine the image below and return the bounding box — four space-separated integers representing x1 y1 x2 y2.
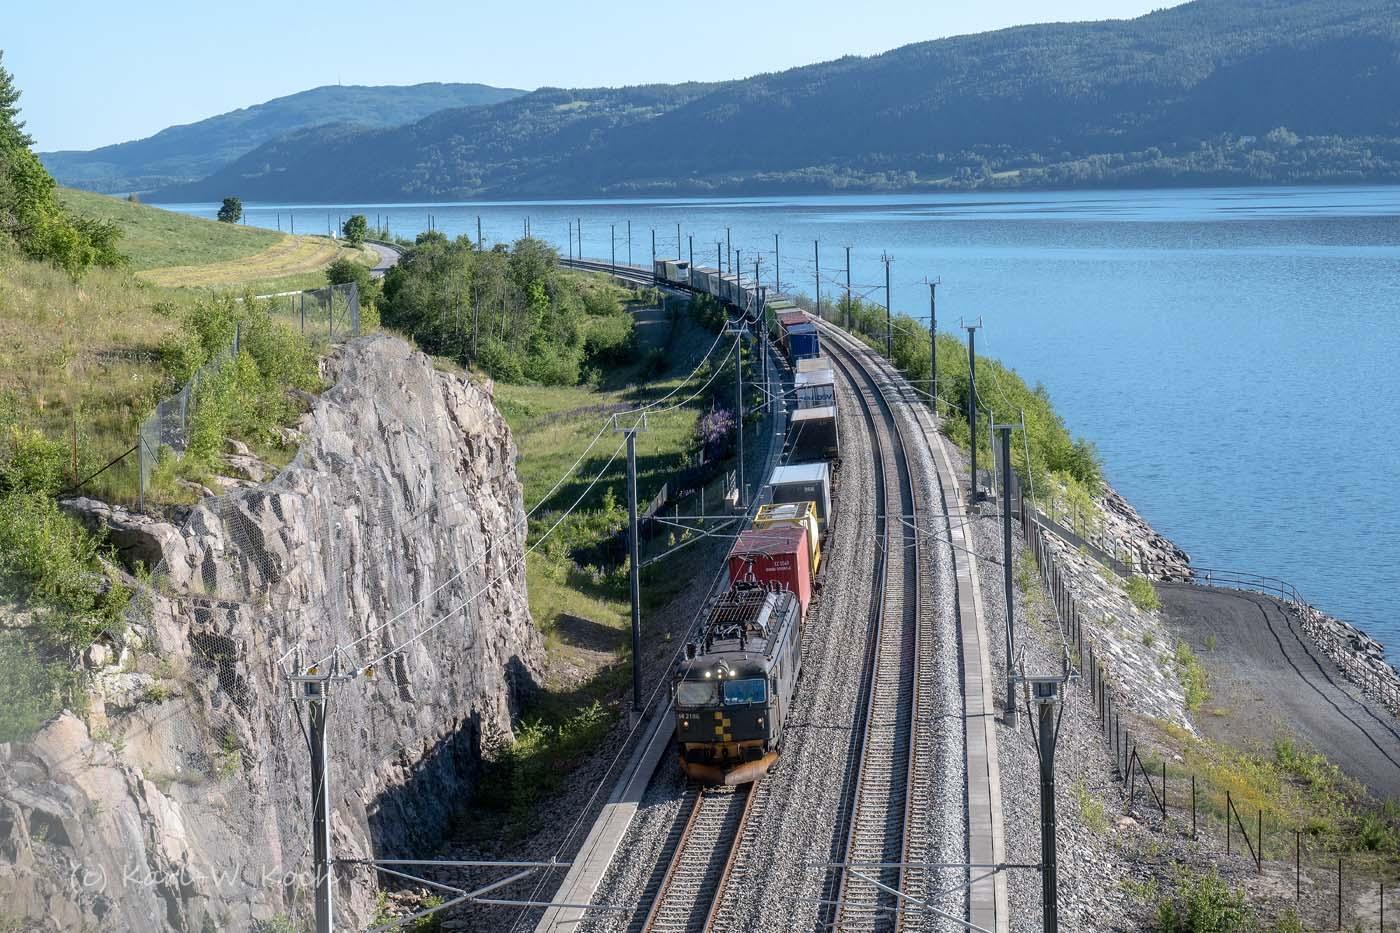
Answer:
0 336 543 930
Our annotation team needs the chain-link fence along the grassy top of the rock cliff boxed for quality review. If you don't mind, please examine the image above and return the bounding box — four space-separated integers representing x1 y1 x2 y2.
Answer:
136 282 360 509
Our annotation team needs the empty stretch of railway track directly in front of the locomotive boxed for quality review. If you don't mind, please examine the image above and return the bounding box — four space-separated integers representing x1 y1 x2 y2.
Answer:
636 782 762 933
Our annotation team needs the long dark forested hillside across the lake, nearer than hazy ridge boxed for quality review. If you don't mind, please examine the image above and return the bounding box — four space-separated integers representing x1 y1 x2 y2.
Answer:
157 0 1400 200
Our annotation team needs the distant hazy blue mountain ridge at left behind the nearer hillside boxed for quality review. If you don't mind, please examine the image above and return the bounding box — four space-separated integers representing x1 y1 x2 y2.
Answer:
39 83 525 193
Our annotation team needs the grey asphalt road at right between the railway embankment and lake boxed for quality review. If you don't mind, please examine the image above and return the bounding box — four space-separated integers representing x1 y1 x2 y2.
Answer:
1158 583 1400 797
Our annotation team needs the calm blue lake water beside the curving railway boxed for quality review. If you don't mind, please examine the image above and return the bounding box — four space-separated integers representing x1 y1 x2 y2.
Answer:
158 188 1400 657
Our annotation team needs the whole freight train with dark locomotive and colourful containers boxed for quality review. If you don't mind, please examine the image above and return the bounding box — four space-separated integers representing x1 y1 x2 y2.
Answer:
652 252 840 785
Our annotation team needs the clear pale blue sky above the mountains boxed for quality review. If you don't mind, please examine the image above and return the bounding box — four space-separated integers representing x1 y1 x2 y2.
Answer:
13 0 1179 150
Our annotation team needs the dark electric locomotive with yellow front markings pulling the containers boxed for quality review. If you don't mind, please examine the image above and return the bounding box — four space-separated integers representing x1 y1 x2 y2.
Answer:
672 580 802 785
